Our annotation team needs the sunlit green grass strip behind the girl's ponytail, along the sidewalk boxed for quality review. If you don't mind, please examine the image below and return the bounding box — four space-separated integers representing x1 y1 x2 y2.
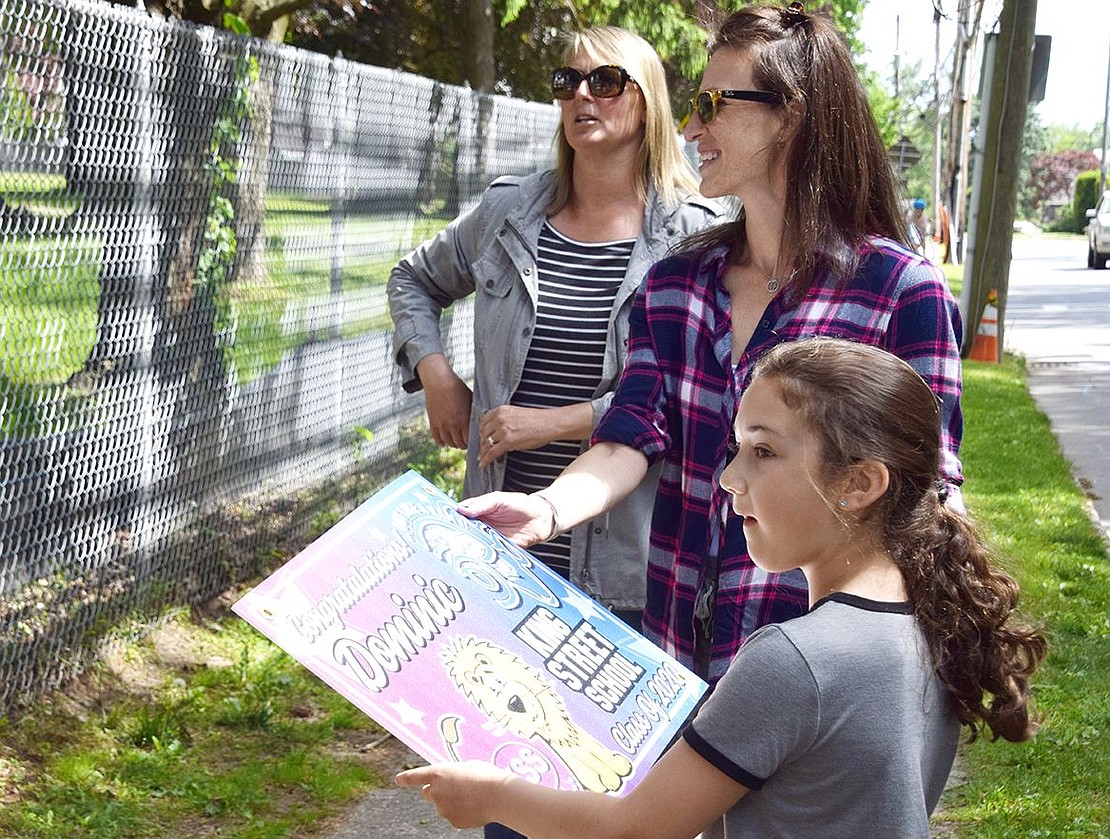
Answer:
944 357 1110 839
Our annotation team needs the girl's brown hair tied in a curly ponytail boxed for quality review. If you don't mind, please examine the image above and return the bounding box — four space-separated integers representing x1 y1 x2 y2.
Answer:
754 337 1047 741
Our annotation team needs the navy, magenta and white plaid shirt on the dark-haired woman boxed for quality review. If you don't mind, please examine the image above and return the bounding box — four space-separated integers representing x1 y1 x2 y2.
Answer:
593 239 963 681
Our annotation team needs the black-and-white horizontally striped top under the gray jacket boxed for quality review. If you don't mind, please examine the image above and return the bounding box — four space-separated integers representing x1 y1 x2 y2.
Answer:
504 223 636 577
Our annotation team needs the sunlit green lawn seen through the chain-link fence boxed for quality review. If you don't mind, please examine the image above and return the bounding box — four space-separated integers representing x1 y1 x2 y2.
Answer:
0 201 446 401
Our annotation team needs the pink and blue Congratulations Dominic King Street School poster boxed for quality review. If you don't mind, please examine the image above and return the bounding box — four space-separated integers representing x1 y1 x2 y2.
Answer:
232 472 706 795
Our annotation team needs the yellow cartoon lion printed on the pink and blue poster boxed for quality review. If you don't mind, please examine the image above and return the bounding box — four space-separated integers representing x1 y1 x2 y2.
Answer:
443 638 632 792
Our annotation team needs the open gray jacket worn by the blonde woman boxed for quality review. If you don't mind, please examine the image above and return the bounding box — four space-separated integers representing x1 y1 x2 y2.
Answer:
389 171 722 609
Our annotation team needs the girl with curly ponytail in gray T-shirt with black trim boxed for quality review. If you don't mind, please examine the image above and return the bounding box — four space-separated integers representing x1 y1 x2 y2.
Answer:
397 337 1046 839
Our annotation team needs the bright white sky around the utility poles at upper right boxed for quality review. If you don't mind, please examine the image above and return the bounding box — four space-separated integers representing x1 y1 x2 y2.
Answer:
859 0 1110 129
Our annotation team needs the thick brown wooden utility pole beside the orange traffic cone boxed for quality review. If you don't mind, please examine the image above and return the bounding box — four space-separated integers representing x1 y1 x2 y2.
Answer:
960 0 1037 361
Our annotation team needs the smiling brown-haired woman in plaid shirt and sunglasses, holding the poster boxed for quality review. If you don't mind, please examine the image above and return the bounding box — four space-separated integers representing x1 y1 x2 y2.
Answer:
460 3 962 683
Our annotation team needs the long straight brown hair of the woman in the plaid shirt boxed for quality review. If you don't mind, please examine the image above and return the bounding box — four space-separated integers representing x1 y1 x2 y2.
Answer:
687 4 909 293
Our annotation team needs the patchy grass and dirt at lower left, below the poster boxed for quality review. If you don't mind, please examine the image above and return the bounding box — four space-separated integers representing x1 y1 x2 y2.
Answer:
0 614 385 839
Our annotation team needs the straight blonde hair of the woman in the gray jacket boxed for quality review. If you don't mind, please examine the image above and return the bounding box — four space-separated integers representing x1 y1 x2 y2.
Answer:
547 27 698 214
